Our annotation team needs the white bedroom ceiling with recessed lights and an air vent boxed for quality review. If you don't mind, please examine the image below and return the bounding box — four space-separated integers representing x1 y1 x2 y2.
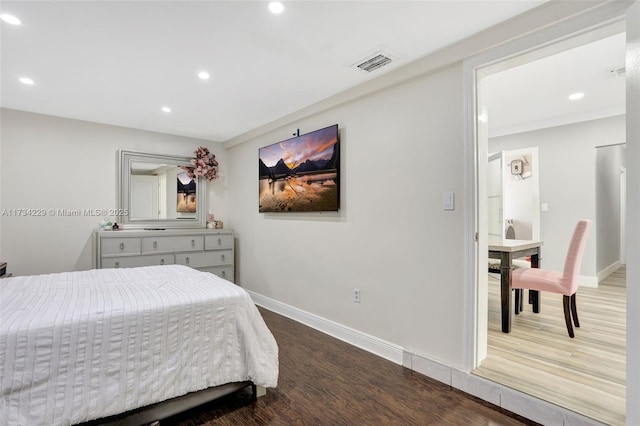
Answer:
0 0 561 142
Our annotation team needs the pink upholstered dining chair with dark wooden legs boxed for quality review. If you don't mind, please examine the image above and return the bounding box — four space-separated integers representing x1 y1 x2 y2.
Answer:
511 220 591 337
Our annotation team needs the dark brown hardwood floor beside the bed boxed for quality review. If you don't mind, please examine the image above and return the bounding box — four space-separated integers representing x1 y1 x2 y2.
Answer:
161 309 534 426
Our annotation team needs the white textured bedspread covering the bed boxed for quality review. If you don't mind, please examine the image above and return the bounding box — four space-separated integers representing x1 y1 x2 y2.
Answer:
0 265 278 426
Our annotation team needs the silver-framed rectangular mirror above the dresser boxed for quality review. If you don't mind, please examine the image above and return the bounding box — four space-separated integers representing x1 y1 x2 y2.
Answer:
119 150 206 229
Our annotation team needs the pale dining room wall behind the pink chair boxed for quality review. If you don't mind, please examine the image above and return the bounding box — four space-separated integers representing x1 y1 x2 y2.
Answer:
489 116 625 280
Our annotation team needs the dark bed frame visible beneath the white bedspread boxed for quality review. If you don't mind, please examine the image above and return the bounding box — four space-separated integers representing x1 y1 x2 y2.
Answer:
79 382 266 426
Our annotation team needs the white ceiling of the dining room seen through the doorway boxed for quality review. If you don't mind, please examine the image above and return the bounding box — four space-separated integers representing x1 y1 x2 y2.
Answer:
484 31 626 137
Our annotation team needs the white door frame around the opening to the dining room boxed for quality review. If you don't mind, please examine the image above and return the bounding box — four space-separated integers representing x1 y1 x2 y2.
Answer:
463 0 640 424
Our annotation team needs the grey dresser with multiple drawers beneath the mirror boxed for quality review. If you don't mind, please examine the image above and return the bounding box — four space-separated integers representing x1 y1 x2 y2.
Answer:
95 229 235 282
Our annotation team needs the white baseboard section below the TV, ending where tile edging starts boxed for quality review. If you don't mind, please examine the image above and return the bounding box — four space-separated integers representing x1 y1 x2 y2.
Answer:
247 290 402 365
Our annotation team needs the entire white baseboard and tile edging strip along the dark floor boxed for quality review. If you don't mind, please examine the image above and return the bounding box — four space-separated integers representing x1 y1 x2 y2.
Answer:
247 290 602 426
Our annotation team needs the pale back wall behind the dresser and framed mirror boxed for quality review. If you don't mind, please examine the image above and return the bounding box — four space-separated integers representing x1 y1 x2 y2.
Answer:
0 109 227 275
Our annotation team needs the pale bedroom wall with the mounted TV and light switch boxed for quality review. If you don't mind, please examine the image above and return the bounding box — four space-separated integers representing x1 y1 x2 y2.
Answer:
225 64 465 367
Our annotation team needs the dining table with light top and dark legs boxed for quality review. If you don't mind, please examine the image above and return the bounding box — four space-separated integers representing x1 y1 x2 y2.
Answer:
488 235 543 333
